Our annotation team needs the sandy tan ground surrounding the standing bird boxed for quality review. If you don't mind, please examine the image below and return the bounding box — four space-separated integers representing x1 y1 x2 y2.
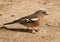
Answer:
0 0 60 42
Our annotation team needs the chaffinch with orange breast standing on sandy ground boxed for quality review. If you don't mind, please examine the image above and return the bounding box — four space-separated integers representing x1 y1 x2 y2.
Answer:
4 9 48 32
